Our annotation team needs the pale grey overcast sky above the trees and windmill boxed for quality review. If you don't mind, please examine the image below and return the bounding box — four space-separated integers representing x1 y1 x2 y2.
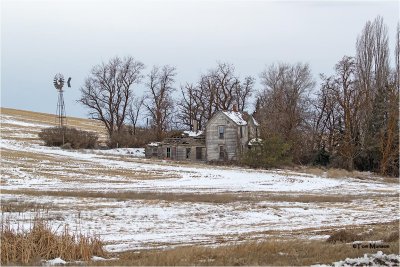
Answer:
1 0 399 117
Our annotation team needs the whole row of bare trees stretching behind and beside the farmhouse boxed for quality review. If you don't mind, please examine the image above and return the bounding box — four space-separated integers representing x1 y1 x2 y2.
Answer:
78 17 400 176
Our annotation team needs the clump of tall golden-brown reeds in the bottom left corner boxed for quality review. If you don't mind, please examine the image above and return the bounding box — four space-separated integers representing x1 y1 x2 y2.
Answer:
1 217 105 265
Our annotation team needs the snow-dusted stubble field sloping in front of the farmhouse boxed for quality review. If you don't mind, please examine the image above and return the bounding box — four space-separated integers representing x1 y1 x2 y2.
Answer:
0 115 399 251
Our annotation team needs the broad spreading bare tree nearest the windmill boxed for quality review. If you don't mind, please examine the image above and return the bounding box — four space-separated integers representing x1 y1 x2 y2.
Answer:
78 57 144 136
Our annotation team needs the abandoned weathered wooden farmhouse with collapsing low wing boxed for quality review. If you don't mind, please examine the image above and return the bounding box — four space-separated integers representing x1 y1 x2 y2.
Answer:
145 109 260 161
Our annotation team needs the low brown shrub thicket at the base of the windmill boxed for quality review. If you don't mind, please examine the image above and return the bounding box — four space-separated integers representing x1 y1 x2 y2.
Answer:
39 127 98 149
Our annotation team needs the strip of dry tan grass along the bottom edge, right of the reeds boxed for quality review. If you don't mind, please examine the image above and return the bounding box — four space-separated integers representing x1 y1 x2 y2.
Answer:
96 240 399 266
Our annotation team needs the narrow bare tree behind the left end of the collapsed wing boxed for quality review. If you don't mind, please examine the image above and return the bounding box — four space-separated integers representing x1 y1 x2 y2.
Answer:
143 65 176 140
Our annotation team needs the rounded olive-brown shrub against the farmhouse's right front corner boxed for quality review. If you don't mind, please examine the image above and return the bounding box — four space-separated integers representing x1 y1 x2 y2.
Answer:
240 136 291 168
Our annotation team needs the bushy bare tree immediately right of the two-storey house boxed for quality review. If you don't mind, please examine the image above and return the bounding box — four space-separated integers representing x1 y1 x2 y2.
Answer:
255 63 315 162
